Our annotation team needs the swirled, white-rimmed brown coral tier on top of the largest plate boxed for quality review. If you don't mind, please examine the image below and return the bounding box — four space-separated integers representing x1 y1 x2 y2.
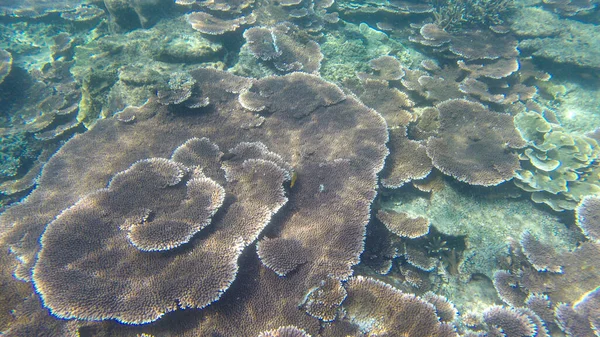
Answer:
33 139 289 324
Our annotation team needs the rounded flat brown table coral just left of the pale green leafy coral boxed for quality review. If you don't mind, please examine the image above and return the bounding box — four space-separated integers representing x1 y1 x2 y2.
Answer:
427 99 525 186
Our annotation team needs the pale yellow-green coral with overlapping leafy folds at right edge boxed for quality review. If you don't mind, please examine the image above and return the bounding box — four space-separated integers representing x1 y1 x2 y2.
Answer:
515 112 600 211
